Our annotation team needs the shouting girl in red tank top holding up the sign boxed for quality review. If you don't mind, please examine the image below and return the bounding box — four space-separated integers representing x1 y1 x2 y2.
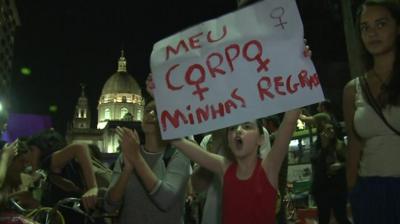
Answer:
172 110 299 224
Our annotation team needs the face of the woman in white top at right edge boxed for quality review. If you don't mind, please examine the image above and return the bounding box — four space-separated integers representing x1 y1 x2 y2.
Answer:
360 6 400 56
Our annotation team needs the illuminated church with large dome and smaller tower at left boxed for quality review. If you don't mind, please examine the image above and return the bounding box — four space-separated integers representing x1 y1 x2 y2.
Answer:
66 51 144 153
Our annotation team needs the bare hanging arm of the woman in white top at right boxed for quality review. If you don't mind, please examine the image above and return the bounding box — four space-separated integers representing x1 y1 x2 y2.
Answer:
343 80 363 189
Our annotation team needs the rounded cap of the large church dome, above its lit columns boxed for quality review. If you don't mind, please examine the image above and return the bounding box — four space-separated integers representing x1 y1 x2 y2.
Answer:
101 71 142 95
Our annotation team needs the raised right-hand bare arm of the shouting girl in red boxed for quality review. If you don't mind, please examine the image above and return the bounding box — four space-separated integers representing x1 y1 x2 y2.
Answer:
262 109 300 188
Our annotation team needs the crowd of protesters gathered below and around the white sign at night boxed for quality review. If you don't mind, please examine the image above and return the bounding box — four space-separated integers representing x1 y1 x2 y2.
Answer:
0 0 400 224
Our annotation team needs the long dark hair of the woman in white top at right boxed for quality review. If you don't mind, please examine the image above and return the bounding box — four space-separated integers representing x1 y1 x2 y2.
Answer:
356 0 400 107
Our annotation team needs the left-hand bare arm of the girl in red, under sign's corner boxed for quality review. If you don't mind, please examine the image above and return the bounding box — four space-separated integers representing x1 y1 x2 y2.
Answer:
171 139 227 177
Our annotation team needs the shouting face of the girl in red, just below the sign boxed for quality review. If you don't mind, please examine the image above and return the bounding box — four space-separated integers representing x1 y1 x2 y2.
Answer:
227 121 264 158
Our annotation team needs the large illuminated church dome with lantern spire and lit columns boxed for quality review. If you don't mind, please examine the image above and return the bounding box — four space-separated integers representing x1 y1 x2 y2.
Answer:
97 51 144 129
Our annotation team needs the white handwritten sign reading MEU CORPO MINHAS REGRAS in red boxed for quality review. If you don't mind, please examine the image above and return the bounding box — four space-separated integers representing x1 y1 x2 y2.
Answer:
151 0 324 139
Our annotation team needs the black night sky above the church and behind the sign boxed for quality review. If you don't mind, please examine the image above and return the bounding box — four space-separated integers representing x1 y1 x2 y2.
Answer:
11 0 345 133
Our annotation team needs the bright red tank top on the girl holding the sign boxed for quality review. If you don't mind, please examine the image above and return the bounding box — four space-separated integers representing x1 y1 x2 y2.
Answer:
222 159 276 224
